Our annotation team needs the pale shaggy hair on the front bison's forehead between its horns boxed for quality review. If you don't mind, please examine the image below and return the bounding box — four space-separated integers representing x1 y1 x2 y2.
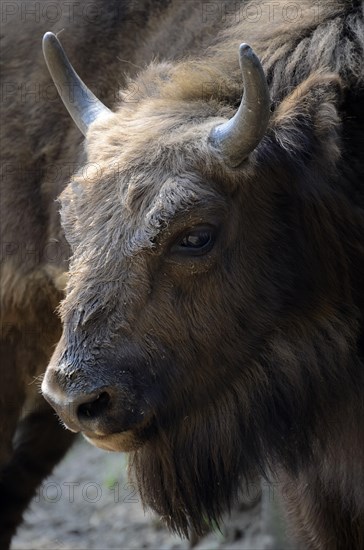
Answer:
61 88 239 244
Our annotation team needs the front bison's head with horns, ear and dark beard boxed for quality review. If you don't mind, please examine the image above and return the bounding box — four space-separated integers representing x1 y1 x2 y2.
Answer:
42 32 351 533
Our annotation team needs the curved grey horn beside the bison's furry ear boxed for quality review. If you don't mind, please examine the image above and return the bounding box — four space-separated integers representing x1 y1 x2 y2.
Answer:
209 44 270 168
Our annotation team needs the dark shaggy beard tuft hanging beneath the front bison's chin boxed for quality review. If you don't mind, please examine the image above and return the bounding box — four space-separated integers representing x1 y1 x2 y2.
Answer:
130 396 260 537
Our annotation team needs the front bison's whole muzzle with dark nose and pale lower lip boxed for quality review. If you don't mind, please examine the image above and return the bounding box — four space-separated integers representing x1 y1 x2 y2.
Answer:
42 340 153 451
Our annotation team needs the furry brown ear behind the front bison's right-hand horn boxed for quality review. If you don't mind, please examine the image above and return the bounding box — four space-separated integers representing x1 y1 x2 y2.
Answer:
270 72 342 167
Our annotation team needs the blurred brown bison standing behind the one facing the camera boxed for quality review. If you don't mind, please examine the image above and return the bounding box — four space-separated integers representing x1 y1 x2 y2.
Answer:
0 0 225 549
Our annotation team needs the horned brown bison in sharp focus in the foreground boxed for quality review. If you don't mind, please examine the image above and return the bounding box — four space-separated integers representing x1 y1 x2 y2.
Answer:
1 0 364 550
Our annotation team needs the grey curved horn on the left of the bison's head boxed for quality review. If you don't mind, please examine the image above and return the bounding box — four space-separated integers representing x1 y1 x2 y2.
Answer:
43 32 111 136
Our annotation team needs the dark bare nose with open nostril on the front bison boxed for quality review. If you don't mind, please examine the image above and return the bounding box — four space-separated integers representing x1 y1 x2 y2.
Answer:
42 371 145 435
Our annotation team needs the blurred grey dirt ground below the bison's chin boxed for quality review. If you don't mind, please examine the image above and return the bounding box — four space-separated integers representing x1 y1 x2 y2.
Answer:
11 439 294 550
